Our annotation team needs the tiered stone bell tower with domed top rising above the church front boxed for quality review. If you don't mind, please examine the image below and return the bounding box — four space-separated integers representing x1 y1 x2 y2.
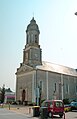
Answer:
23 17 42 67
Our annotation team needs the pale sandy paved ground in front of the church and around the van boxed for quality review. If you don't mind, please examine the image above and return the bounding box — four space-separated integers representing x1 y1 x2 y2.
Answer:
0 105 77 119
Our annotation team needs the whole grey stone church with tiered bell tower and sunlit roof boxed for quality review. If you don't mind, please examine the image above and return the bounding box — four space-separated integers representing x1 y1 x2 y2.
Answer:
16 17 77 105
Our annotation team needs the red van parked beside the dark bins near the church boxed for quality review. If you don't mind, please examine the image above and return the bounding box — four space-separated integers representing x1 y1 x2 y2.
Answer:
41 100 64 118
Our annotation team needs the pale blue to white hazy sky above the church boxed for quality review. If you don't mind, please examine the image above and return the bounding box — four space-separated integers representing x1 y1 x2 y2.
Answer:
0 0 77 91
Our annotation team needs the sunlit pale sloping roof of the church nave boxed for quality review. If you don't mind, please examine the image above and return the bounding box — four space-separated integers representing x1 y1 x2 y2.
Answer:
36 61 77 76
